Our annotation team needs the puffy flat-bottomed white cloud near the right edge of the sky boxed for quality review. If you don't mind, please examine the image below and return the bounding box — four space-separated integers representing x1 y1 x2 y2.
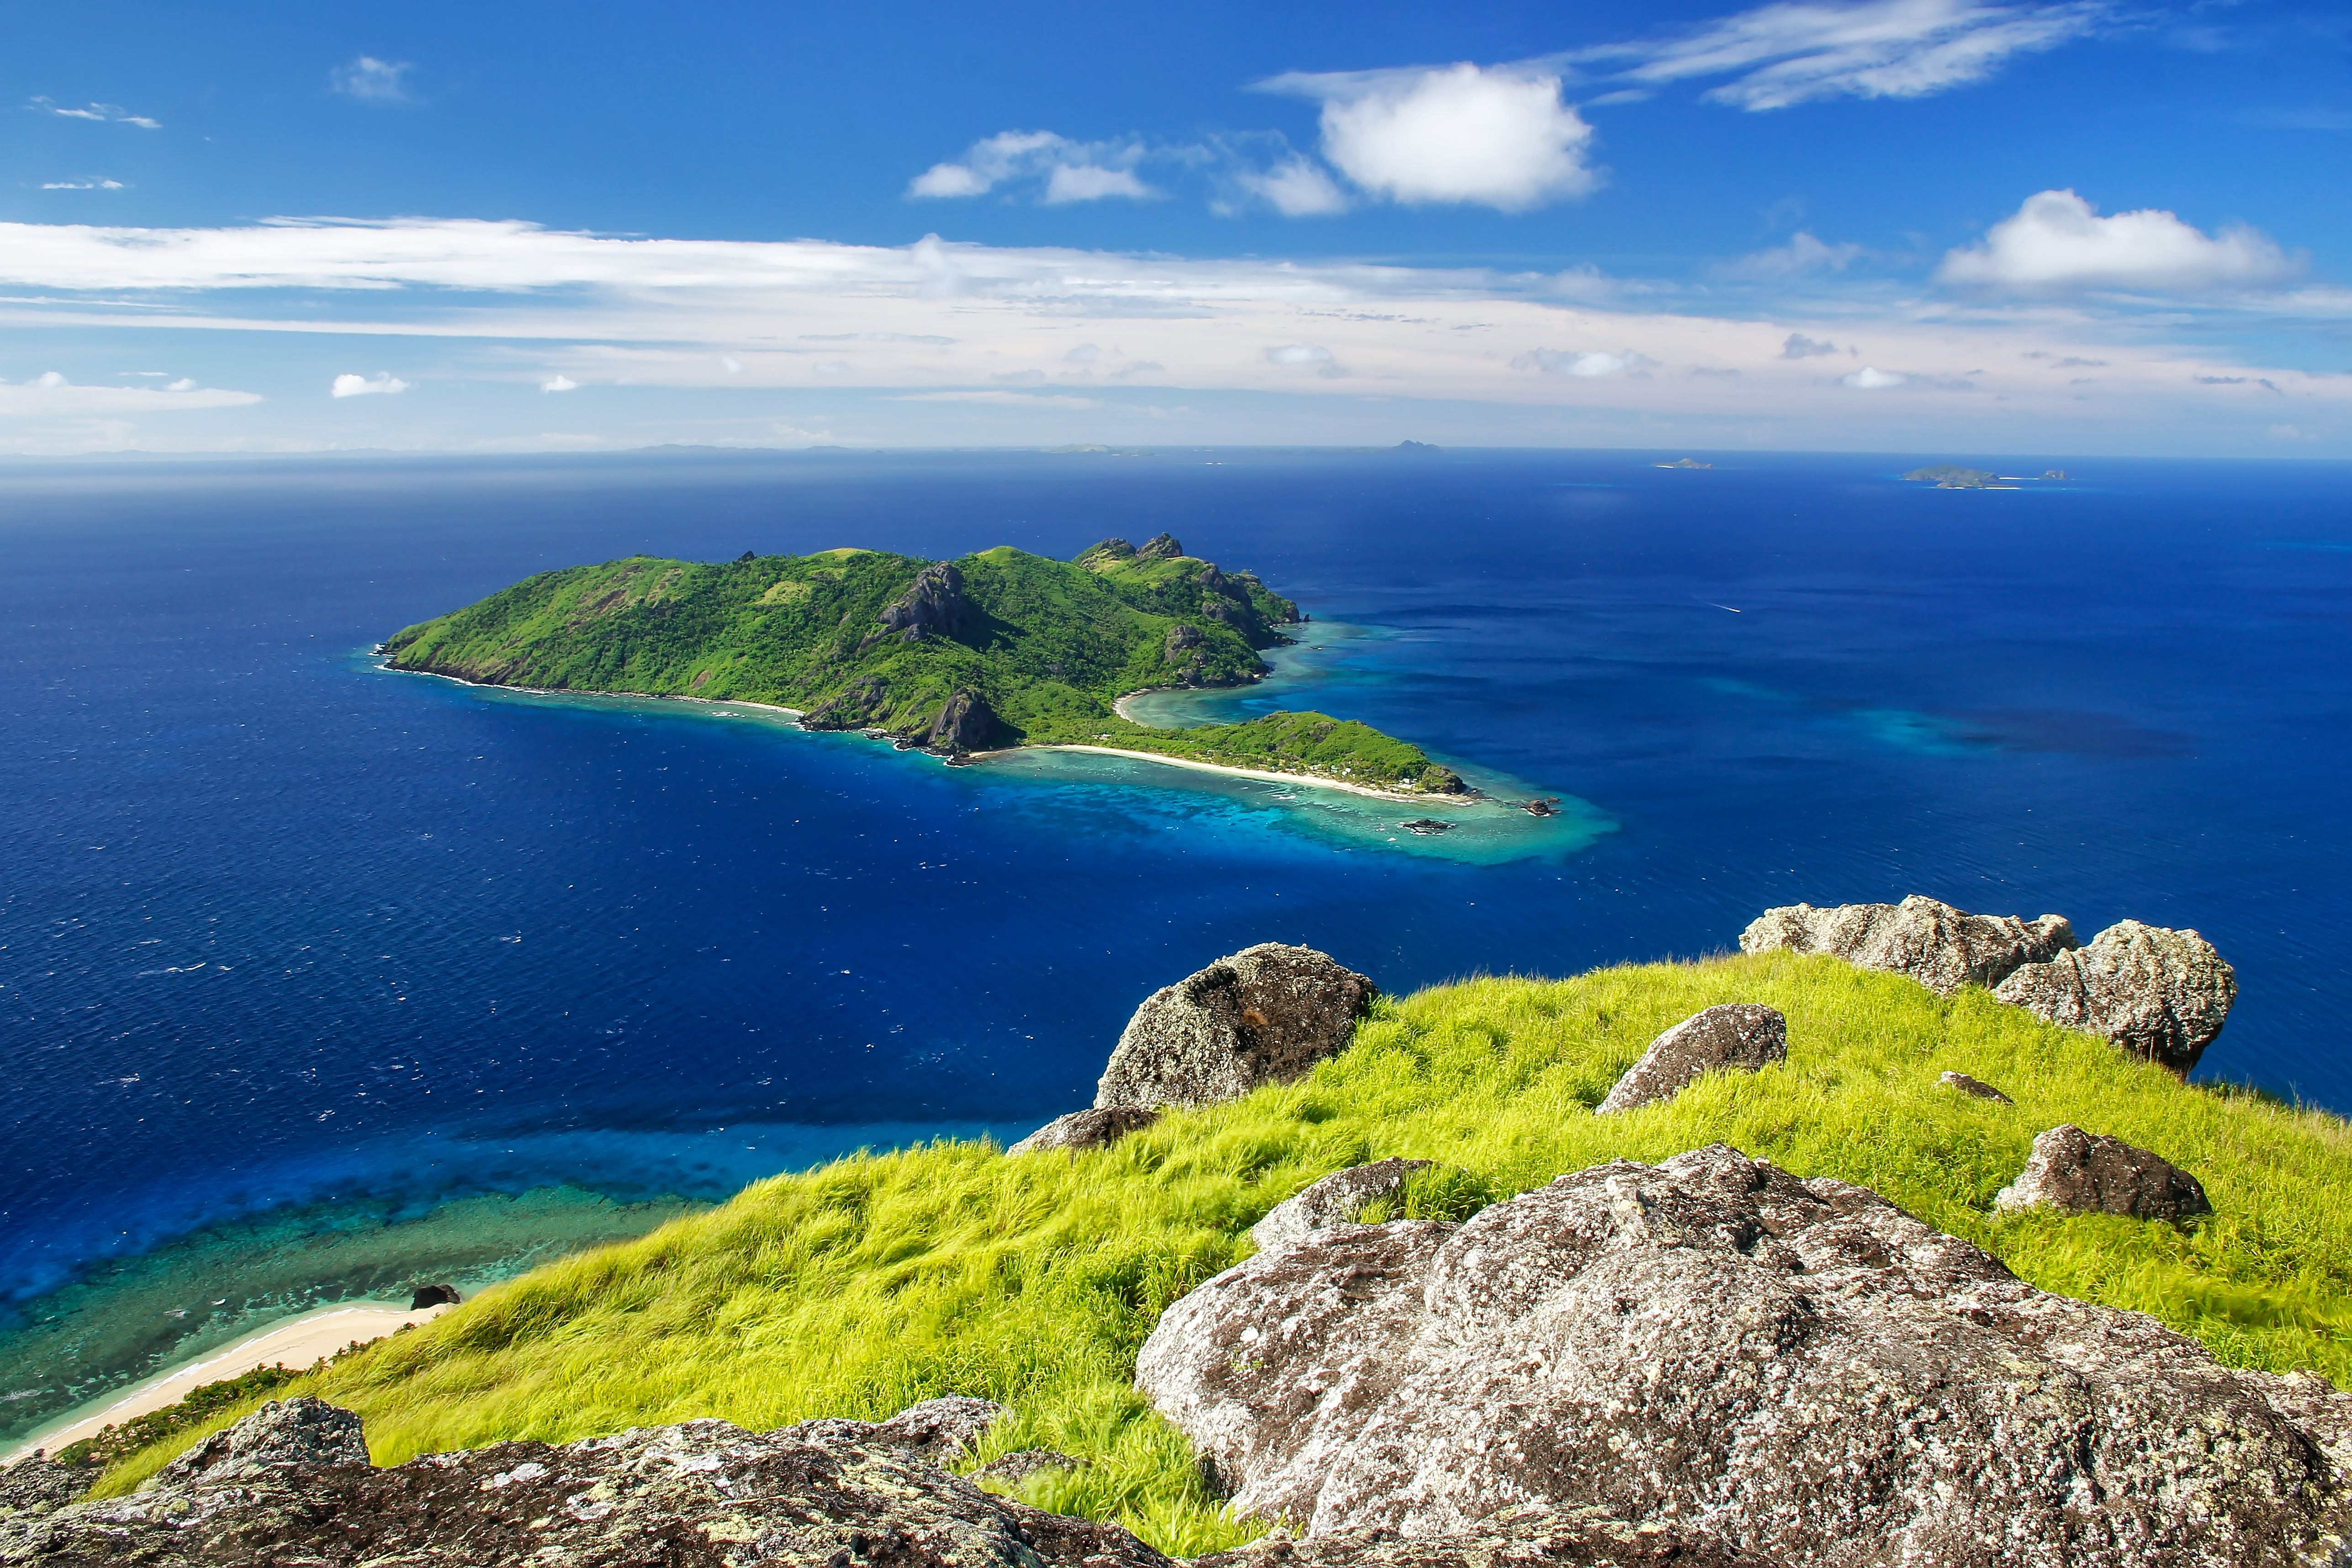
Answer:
1936 190 2300 294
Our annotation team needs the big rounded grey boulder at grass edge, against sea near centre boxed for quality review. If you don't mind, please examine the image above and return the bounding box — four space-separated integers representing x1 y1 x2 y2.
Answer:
1094 943 1380 1107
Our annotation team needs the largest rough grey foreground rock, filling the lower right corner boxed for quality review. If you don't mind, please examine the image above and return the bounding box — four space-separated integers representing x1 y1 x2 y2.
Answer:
1136 1145 2352 1568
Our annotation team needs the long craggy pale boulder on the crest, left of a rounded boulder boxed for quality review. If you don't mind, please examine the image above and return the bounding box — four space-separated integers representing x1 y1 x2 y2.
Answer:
1740 893 2074 997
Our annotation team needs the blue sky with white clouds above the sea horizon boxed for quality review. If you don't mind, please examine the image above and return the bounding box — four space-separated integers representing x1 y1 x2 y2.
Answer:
0 0 2352 459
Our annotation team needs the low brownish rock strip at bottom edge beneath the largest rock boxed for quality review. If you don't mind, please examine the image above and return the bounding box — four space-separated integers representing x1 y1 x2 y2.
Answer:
1193 1507 1776 1568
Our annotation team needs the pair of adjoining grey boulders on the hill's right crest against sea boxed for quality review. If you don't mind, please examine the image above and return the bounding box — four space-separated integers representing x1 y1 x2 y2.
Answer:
1740 893 2237 1077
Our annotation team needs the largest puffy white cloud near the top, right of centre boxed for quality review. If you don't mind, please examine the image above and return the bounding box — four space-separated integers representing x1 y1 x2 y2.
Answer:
1261 63 1599 211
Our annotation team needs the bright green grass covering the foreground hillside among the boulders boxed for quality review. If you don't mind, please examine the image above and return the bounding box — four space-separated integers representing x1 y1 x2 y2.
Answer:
83 955 2352 1554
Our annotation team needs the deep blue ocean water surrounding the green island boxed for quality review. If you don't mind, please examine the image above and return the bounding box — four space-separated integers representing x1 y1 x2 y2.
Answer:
0 451 2352 1429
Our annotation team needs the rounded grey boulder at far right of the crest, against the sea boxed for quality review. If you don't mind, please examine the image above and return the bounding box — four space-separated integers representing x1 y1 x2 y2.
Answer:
1992 919 2237 1077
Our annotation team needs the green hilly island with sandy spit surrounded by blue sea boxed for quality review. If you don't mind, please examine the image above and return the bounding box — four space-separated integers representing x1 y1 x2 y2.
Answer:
381 533 1470 799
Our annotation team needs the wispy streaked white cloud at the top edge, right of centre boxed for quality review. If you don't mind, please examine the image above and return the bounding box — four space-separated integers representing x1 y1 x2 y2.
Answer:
1590 0 2110 111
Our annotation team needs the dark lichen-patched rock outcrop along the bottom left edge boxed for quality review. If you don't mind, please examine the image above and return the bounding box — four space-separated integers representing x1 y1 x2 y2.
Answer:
0 1410 1169 1568
